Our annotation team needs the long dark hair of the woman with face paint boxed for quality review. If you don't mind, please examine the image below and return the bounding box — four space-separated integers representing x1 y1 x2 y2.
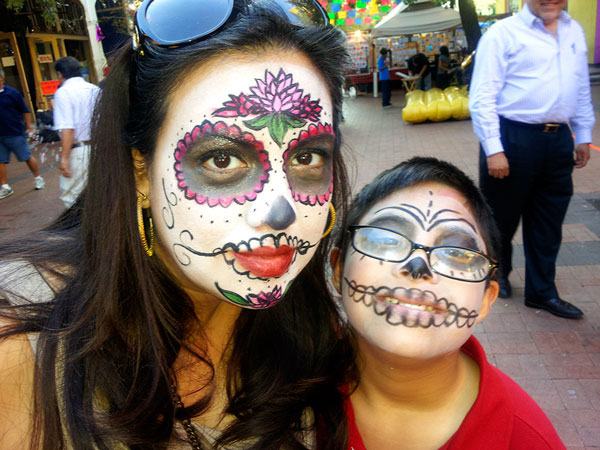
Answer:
0 0 353 449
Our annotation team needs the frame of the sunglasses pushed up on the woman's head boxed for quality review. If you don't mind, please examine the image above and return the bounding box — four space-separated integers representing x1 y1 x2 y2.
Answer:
133 0 330 50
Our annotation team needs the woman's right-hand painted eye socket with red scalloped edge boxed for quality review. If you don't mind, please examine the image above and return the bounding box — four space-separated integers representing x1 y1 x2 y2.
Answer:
283 123 335 206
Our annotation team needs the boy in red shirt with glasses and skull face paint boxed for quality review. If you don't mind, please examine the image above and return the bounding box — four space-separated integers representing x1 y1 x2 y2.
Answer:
331 158 565 450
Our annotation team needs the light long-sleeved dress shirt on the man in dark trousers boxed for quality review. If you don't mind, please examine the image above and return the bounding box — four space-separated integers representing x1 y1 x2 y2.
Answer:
469 4 595 156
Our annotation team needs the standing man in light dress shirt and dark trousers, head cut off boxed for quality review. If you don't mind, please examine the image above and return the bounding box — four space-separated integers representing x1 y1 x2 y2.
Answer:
469 0 595 319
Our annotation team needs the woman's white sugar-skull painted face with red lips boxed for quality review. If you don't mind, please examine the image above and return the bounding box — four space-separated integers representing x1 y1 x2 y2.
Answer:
150 51 335 308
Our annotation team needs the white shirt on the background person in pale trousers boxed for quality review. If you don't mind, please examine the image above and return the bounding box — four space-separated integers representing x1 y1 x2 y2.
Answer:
53 77 100 142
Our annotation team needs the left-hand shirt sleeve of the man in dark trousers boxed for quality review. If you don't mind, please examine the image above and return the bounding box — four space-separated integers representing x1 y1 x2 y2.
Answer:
469 26 507 156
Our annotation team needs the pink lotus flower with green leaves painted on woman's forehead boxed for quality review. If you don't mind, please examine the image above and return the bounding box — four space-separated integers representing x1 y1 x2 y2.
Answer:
213 69 323 145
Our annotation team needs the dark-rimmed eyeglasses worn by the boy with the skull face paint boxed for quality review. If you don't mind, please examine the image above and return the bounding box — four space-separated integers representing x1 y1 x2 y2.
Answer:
349 225 498 283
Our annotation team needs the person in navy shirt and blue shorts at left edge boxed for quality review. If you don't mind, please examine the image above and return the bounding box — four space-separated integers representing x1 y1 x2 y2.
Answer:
0 68 45 199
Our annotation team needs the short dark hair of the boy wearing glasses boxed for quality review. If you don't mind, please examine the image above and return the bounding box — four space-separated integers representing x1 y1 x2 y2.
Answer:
336 157 500 266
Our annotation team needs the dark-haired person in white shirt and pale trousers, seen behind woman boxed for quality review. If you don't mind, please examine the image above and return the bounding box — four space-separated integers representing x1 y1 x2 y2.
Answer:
54 56 100 208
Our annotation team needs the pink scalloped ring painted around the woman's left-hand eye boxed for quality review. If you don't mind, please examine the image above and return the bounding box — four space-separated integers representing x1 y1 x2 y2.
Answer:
173 120 271 208
